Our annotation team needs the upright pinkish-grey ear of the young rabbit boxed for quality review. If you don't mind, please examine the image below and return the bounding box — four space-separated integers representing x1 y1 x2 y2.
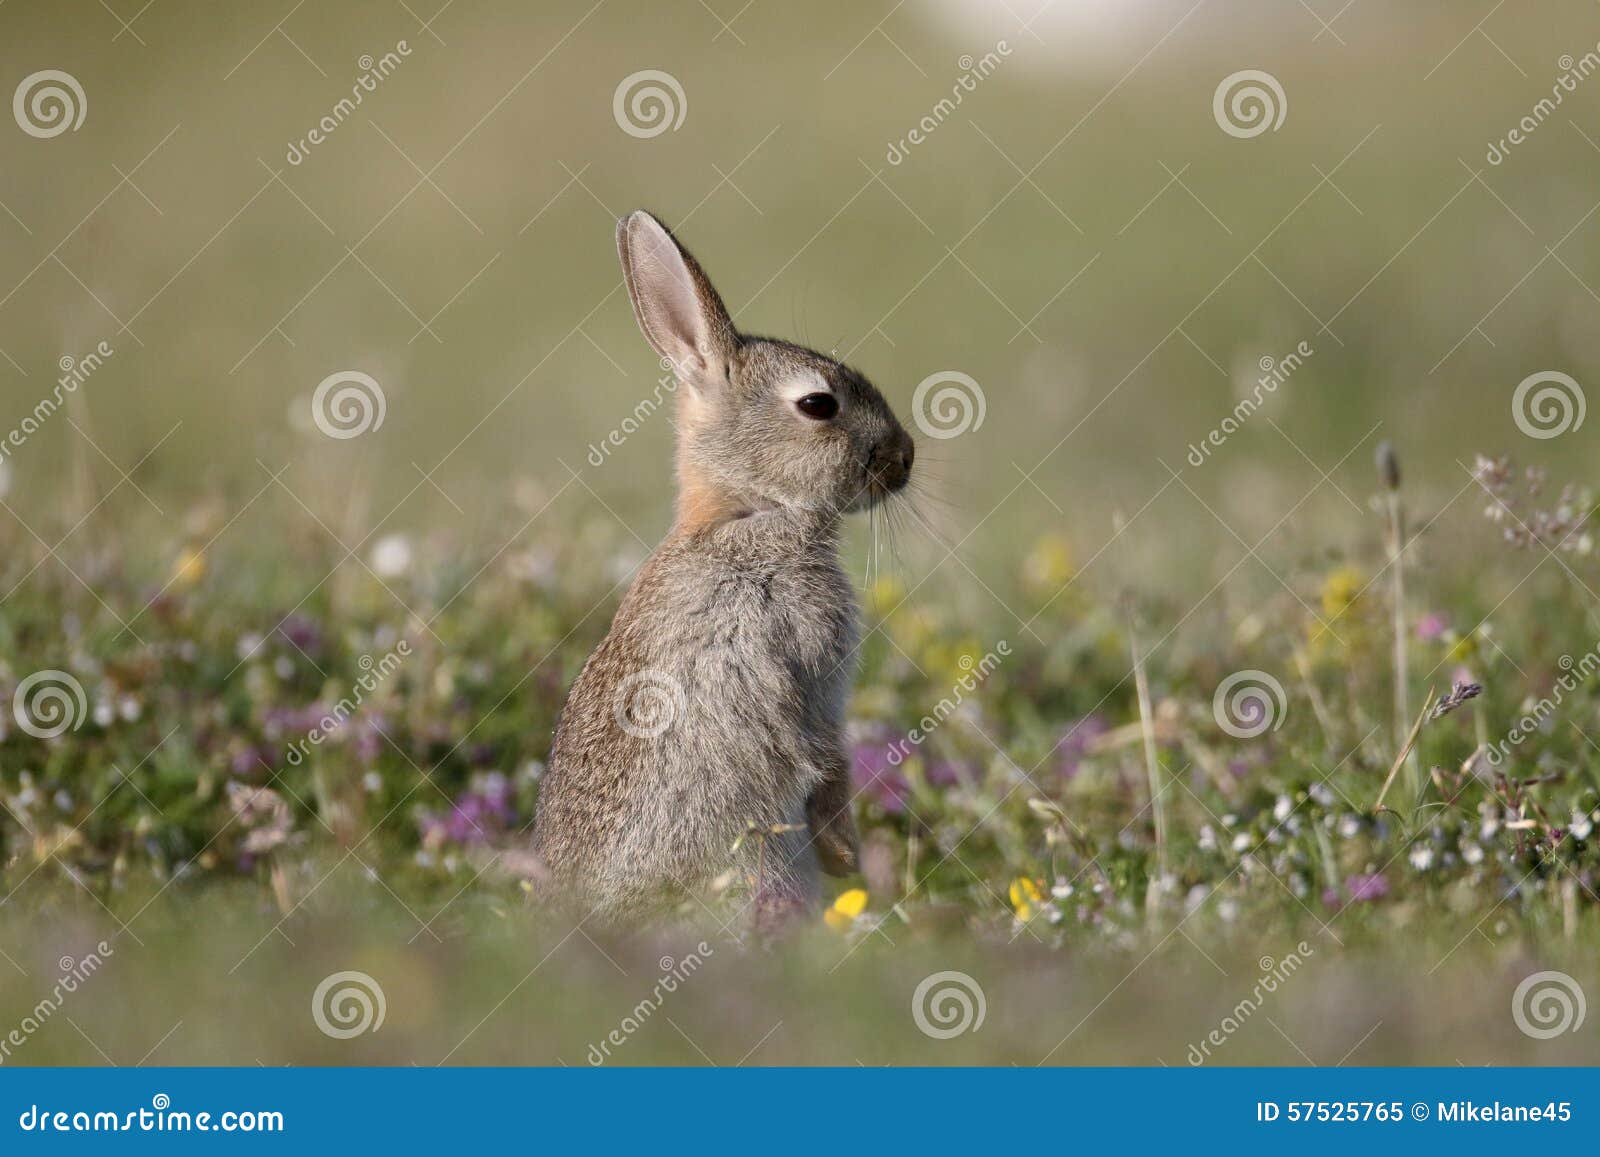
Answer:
616 210 739 387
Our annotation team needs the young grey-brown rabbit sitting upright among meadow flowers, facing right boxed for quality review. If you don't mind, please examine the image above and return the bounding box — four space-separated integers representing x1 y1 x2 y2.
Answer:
533 211 915 917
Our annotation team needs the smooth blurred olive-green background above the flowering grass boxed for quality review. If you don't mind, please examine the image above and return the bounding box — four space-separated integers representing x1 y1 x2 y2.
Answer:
0 0 1600 601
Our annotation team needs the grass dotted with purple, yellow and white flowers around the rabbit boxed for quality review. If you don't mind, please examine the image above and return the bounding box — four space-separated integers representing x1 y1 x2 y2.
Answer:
0 444 1600 1064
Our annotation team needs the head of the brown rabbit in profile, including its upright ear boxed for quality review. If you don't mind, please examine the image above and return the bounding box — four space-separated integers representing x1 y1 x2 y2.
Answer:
616 211 915 522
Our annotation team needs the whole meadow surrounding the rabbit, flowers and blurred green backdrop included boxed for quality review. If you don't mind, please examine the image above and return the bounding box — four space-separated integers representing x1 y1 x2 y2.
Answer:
0 0 1600 1068
